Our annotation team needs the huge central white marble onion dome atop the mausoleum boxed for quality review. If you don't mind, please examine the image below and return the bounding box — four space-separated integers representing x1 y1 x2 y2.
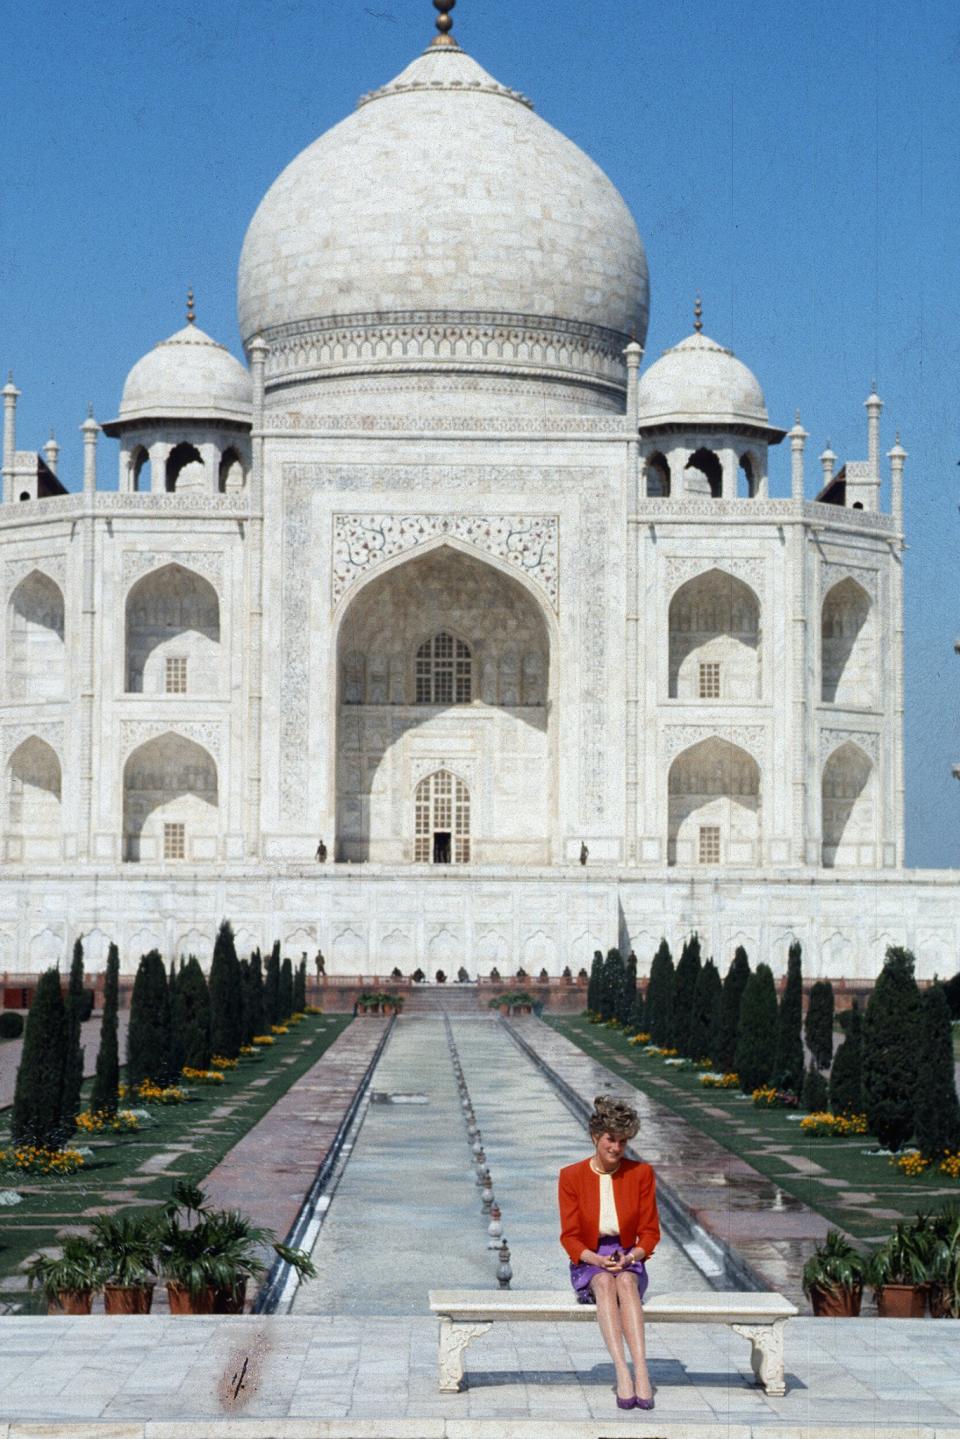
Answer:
237 47 648 411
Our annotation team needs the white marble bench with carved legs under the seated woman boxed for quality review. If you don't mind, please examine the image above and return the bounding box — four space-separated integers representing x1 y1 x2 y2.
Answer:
429 1289 799 1396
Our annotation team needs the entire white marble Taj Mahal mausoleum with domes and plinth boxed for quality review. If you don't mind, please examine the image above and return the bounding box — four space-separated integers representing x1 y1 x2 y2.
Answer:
0 4 960 979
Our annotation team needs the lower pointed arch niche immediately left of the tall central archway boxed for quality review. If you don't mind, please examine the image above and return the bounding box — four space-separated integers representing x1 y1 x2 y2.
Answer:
124 731 220 863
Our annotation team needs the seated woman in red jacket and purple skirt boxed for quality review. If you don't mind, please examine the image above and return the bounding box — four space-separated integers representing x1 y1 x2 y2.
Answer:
558 1095 661 1409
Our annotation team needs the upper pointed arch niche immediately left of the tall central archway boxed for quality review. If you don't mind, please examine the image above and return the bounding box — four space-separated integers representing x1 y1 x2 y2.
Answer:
125 564 220 695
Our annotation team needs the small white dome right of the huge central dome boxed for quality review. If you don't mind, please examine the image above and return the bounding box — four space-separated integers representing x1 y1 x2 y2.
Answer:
638 331 770 429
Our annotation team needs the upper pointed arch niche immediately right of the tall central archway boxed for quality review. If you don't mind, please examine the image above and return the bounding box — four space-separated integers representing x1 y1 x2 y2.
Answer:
668 570 761 704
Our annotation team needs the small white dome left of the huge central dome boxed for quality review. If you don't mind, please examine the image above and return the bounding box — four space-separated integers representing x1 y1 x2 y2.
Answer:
118 324 253 425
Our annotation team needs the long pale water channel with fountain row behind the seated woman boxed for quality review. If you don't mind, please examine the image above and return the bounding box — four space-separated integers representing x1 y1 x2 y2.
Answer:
292 1014 708 1317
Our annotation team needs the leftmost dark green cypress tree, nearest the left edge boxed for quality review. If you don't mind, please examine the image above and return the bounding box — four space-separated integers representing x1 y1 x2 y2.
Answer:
10 970 68 1148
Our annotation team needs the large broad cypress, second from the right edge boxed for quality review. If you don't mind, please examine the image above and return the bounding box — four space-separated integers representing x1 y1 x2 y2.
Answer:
862 945 920 1150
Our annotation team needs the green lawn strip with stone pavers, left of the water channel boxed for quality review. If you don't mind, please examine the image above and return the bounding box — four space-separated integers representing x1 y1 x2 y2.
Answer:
0 1014 351 1314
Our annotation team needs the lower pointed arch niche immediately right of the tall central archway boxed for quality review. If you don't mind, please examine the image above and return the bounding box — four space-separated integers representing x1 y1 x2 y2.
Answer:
666 735 760 866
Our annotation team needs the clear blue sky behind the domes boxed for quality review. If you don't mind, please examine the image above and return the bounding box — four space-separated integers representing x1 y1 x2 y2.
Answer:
0 0 960 866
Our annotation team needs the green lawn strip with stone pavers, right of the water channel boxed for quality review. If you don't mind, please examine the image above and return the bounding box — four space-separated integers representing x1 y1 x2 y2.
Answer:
543 1014 960 1239
